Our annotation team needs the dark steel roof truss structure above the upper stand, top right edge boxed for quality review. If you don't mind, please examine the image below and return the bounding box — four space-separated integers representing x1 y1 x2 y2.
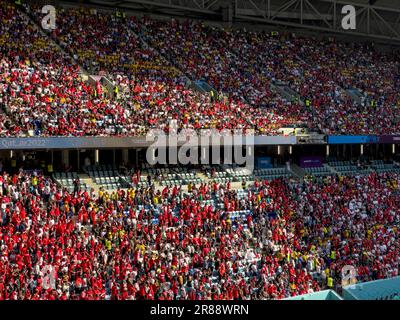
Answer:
78 0 400 44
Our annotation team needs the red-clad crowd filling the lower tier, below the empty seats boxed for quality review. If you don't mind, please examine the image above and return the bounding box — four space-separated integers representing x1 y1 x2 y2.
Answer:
0 170 400 300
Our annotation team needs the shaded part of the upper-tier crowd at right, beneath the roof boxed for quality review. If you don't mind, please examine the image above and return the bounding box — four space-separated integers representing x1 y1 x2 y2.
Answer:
137 17 400 134
